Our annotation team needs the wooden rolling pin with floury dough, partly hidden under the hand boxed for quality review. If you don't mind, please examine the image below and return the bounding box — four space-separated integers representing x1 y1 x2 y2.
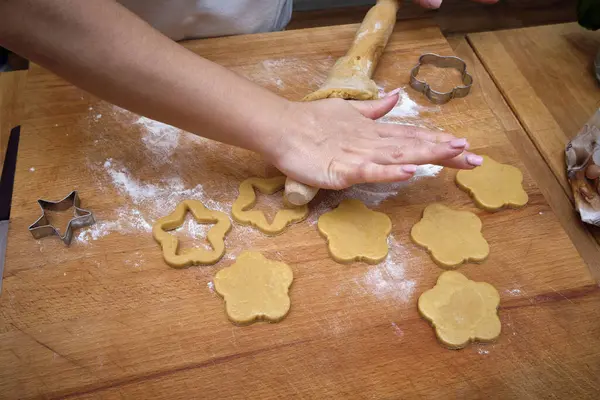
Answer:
285 0 400 206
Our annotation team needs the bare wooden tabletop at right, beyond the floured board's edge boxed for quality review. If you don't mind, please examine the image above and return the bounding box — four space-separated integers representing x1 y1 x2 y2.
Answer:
468 23 600 242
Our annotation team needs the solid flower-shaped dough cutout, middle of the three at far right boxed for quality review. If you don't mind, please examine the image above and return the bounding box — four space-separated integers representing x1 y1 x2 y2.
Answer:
410 203 490 268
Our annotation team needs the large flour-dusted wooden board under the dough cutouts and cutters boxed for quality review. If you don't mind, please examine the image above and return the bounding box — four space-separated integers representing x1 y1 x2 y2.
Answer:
0 22 600 399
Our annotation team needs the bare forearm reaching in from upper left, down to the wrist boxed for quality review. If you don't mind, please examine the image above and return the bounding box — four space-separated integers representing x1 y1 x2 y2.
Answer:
0 0 288 151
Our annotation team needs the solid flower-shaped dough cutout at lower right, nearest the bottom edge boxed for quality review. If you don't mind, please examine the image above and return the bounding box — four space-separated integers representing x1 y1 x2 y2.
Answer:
418 271 501 349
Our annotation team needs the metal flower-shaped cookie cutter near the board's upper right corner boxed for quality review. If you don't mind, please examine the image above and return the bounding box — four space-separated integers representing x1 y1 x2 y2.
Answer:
410 53 473 104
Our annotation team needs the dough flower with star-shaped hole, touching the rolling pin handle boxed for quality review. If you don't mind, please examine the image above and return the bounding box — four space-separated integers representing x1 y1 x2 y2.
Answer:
231 176 308 235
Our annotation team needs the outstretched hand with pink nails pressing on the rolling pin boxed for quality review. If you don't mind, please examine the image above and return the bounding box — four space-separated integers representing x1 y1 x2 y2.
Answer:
261 94 482 189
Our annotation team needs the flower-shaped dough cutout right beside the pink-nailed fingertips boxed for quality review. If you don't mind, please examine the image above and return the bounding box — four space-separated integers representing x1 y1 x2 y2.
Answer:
456 156 529 211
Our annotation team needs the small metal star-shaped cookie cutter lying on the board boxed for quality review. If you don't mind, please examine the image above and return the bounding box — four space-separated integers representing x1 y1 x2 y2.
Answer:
29 190 96 246
